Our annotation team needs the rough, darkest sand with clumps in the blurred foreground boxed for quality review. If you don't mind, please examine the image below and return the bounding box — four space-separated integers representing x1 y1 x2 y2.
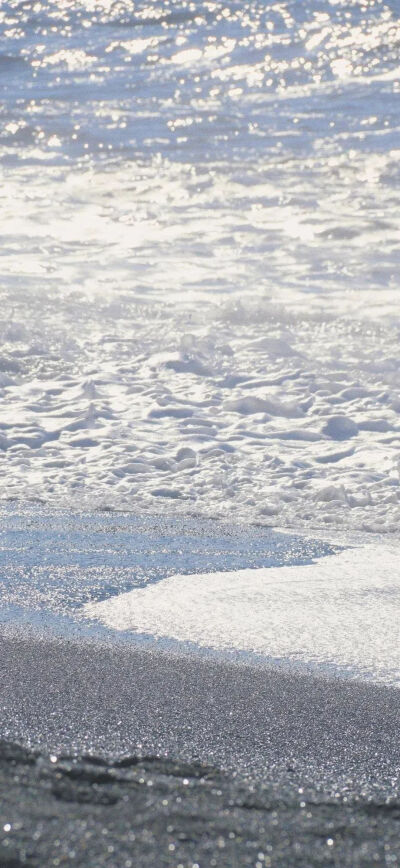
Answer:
0 742 400 868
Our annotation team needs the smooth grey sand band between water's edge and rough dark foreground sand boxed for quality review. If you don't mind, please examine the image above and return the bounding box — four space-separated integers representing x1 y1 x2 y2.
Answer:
0 630 400 795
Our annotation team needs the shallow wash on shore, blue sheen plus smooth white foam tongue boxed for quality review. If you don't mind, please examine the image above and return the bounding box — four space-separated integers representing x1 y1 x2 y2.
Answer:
0 506 400 687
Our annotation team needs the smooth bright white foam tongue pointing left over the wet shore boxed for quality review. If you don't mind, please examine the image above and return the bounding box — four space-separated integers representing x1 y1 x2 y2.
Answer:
84 544 400 686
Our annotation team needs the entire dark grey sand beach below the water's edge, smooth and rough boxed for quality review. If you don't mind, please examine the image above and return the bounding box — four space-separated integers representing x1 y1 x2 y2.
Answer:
0 629 400 868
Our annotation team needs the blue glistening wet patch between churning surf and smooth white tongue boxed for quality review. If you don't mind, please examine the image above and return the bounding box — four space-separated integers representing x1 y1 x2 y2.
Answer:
0 506 335 623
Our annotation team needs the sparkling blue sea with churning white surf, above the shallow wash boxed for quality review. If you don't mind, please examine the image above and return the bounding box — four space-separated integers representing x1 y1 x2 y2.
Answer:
0 0 400 535
